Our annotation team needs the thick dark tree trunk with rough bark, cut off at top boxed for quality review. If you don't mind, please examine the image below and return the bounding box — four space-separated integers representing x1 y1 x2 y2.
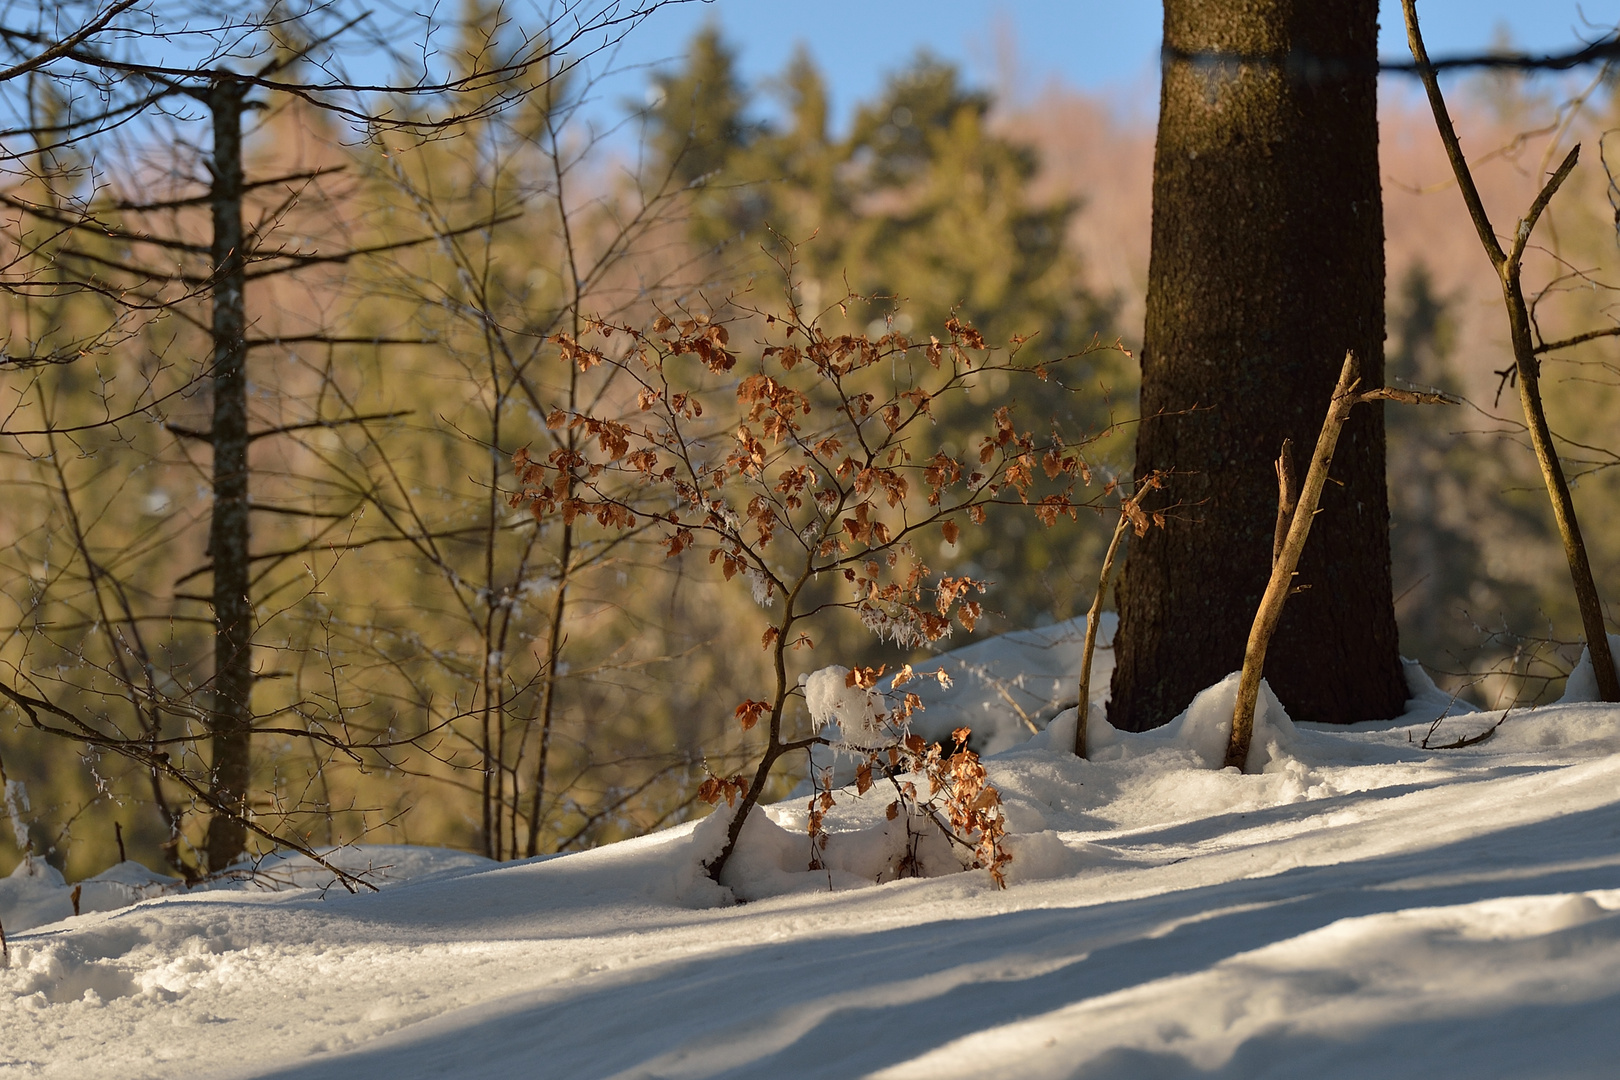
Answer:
1108 0 1406 730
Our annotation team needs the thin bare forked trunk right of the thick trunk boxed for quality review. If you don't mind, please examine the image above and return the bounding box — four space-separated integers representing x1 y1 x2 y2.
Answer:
1401 0 1620 701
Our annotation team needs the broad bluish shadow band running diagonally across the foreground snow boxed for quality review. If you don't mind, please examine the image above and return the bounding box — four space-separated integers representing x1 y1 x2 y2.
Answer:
243 805 1620 1080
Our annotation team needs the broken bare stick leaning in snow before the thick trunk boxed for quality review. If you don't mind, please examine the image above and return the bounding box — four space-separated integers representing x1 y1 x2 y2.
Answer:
1226 353 1450 769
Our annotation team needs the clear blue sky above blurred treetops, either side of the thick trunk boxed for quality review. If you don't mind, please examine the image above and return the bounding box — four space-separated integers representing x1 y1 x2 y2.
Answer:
592 0 1620 128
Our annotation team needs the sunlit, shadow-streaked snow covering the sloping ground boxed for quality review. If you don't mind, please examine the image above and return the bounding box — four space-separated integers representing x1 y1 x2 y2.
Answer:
0 625 1620 1080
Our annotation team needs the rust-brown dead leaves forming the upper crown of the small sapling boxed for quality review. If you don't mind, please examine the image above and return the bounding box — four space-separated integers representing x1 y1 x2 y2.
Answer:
510 299 1121 663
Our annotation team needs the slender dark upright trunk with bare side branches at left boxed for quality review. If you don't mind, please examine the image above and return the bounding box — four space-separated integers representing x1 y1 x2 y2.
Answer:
204 78 253 870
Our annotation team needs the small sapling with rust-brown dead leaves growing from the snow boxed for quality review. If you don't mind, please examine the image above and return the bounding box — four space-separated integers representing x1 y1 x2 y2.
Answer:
510 257 1119 881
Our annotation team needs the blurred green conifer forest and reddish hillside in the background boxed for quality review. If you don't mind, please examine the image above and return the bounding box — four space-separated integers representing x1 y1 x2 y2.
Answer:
0 0 1620 879
